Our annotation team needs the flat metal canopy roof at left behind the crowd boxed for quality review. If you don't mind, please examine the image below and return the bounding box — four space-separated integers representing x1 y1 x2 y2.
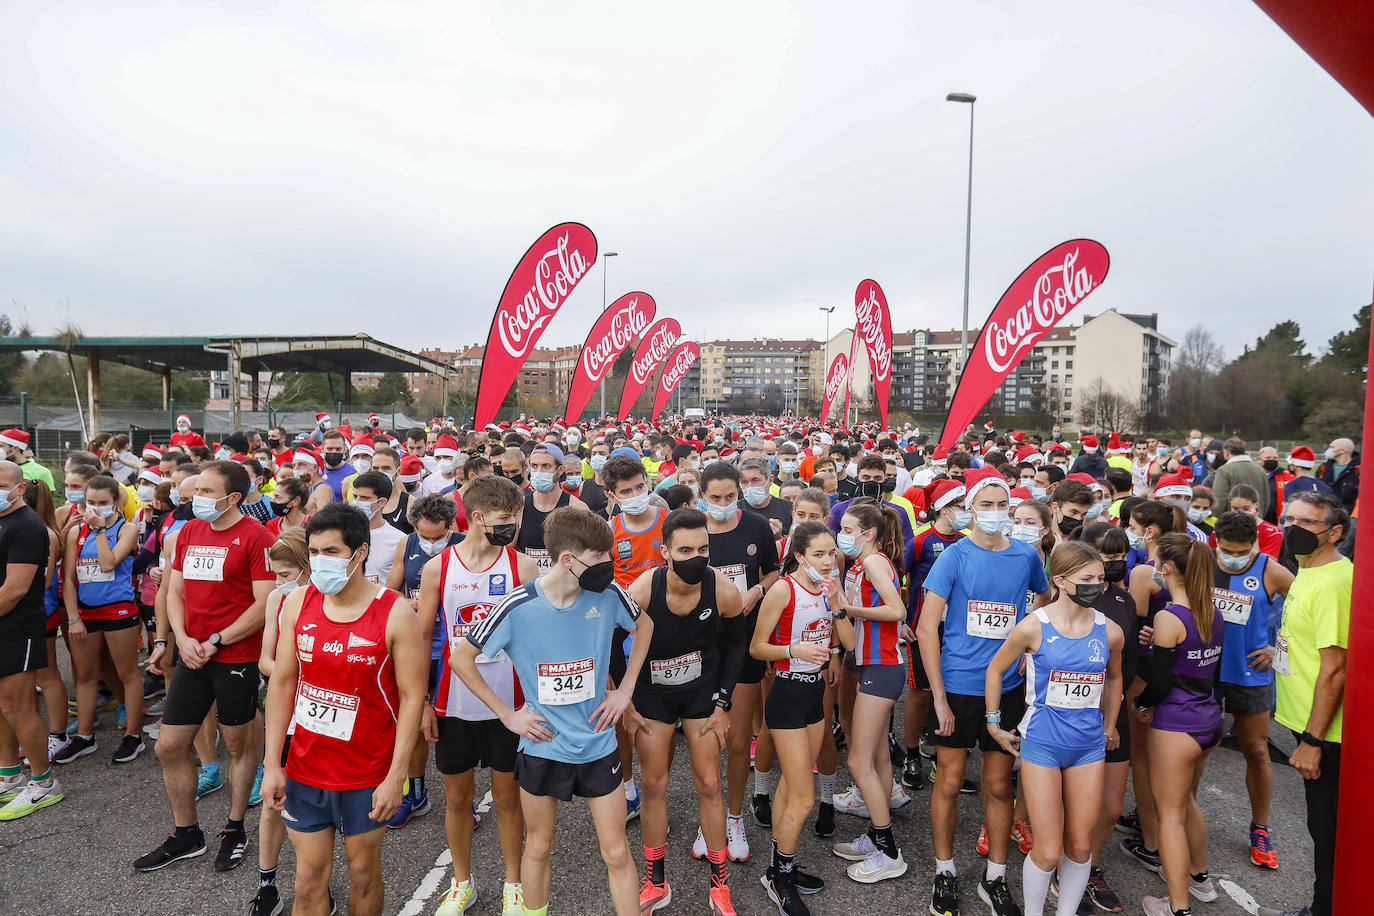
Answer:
0 334 449 378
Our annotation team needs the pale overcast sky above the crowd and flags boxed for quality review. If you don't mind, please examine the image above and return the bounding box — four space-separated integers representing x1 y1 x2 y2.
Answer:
0 0 1374 356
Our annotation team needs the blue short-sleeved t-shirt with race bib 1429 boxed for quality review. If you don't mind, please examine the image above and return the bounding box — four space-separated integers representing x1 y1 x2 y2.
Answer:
925 537 1050 696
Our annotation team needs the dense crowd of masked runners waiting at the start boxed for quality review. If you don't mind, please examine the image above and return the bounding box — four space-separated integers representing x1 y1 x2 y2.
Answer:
0 413 1360 916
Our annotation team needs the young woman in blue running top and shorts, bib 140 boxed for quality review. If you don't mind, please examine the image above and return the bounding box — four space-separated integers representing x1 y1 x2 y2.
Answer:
984 541 1125 916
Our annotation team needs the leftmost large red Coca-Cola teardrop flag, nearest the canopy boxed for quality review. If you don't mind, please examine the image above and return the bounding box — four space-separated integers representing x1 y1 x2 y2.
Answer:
473 222 596 430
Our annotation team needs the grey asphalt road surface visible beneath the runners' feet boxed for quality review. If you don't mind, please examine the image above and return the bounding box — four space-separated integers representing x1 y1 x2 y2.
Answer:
0 683 1312 916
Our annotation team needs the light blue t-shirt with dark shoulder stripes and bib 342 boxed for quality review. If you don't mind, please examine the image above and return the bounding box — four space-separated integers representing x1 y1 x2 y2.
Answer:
467 580 639 764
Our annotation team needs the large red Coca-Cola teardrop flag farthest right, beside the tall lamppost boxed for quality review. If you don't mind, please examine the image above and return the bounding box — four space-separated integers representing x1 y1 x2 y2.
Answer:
940 239 1112 448
